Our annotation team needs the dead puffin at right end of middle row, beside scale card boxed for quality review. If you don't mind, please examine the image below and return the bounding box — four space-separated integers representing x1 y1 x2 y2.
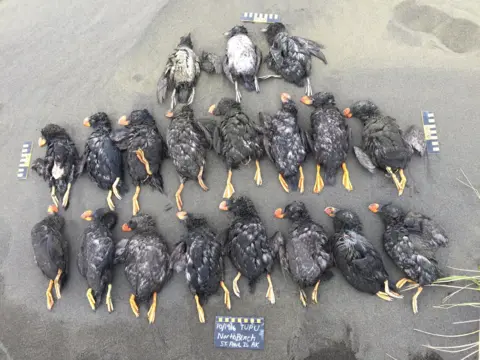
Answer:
343 100 424 195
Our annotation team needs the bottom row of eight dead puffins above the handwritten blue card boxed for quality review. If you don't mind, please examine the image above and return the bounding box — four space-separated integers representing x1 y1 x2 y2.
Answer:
31 196 449 323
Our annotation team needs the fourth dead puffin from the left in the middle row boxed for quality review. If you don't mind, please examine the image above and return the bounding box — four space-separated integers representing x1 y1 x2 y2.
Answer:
167 104 212 211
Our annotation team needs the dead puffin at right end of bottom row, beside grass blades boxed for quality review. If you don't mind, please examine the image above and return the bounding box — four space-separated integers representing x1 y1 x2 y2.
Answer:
369 203 449 314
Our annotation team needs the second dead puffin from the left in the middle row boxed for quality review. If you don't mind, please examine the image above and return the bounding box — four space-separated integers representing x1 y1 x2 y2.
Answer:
79 112 127 210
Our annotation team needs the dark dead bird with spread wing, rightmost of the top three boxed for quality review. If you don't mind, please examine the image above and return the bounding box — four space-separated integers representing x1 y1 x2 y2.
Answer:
262 23 327 96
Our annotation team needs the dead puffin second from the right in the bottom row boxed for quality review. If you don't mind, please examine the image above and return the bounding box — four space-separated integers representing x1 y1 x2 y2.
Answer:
324 206 403 301
